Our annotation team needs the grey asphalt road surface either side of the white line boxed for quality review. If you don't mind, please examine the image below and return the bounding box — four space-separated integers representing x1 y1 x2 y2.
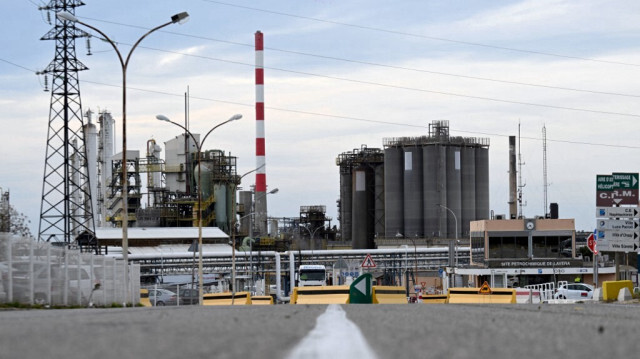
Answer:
0 303 640 359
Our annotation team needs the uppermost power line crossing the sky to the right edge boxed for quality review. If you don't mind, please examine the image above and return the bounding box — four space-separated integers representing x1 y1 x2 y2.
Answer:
202 0 640 67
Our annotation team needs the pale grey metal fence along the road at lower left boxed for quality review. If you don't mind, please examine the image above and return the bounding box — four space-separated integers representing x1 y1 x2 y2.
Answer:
0 233 140 306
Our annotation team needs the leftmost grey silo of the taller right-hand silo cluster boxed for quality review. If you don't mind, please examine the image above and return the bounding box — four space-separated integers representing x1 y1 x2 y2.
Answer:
384 147 404 238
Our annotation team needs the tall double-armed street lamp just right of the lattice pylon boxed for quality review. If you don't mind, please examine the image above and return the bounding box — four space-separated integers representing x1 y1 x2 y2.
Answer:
56 11 189 304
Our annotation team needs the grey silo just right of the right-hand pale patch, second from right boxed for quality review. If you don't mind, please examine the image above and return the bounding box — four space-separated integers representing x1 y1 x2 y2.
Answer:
460 146 476 237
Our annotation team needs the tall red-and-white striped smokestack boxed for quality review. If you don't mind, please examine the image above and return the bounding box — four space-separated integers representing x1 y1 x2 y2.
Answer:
251 31 267 236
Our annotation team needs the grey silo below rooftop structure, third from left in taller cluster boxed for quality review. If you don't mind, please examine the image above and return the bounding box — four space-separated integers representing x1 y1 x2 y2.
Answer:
422 146 440 238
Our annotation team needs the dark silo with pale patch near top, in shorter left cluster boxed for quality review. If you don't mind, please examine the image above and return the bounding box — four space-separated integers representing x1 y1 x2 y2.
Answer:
351 169 368 249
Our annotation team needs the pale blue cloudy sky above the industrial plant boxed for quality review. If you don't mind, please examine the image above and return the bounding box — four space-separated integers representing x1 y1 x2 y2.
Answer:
0 0 640 234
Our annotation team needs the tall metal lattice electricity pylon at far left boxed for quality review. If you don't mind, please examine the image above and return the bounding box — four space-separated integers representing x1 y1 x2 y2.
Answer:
38 0 97 249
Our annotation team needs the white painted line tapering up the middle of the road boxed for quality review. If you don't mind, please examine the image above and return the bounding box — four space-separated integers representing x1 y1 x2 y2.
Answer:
287 304 377 359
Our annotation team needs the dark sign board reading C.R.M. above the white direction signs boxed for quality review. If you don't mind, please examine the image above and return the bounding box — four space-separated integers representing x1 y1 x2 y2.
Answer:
596 172 638 206
